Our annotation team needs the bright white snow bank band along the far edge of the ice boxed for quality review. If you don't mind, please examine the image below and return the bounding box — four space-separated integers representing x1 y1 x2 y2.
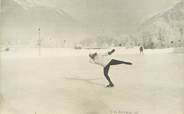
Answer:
1 47 184 58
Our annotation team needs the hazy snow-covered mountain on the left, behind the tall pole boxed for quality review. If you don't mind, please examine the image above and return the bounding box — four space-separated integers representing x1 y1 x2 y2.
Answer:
0 0 83 46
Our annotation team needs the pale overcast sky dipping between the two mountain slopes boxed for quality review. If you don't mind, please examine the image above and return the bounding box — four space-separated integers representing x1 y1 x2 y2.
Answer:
11 0 178 33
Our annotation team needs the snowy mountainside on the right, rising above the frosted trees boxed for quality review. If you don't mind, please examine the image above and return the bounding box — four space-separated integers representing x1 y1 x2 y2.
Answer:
139 0 184 47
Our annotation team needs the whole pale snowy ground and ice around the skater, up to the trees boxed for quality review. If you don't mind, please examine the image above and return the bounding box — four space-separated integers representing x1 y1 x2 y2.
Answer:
0 48 184 114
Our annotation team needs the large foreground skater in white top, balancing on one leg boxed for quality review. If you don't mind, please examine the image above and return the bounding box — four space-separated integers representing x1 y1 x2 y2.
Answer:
89 49 132 87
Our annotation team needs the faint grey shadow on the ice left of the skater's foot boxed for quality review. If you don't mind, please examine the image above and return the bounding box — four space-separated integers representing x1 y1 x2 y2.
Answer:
65 77 104 86
